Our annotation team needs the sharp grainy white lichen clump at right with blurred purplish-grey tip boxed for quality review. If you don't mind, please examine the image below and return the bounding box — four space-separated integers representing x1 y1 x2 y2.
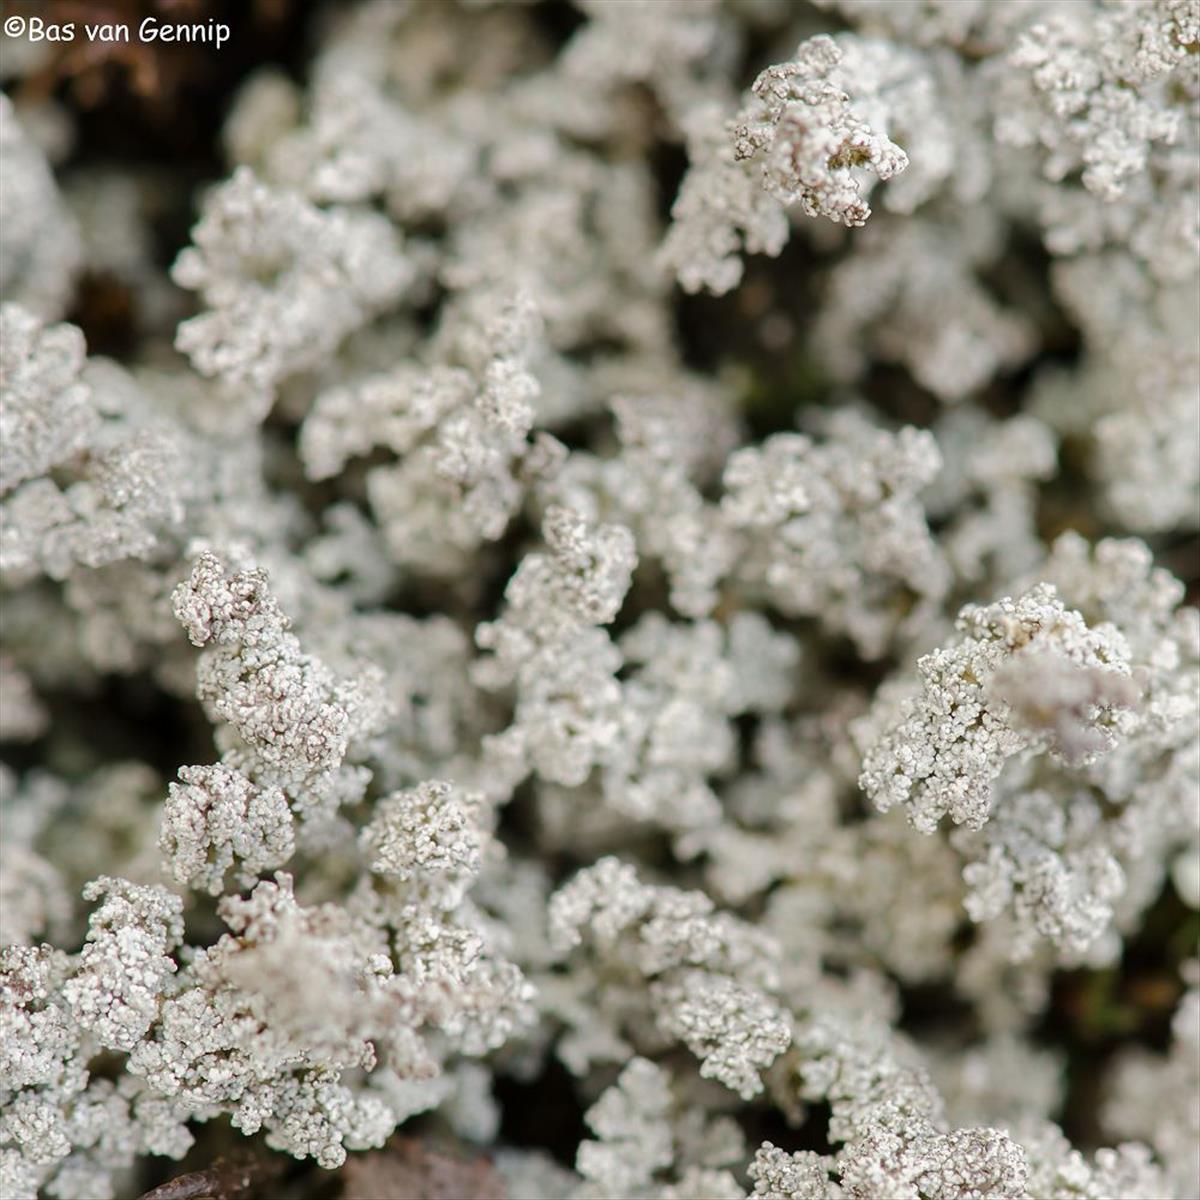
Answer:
860 584 1136 833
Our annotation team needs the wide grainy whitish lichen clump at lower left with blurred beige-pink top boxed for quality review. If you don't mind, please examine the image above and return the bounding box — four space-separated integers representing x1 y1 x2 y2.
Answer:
131 874 528 1166
